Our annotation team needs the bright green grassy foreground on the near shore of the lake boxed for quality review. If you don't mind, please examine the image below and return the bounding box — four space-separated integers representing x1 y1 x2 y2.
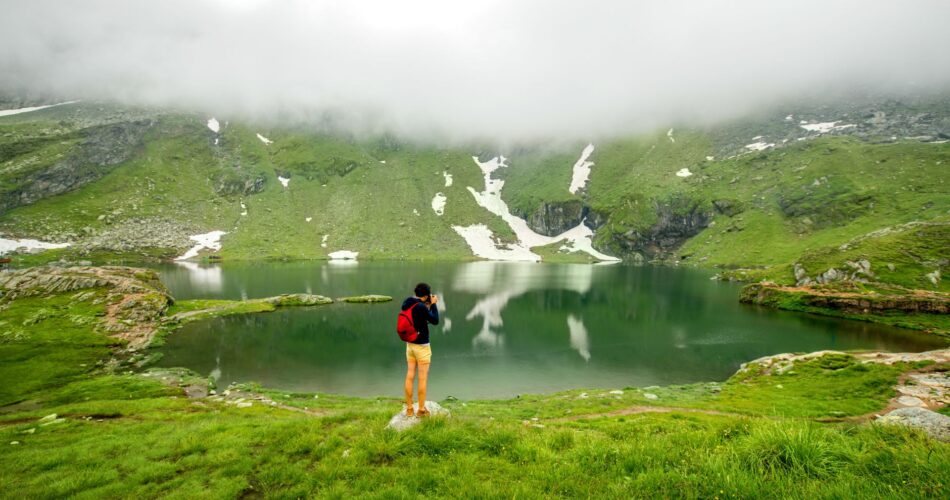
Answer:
0 280 950 498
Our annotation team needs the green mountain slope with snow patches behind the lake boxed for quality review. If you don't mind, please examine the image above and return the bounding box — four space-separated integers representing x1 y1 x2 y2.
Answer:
0 99 950 287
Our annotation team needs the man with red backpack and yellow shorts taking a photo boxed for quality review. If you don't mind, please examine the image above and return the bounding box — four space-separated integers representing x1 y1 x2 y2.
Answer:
402 283 439 417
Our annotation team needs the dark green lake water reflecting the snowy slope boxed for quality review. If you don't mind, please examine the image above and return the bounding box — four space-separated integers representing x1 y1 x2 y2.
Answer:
159 262 941 399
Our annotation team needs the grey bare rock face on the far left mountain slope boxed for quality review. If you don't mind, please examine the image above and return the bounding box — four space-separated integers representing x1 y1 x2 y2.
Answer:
0 119 155 214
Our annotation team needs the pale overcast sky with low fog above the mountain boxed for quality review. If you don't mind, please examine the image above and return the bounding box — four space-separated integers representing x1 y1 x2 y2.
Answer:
0 0 950 140
